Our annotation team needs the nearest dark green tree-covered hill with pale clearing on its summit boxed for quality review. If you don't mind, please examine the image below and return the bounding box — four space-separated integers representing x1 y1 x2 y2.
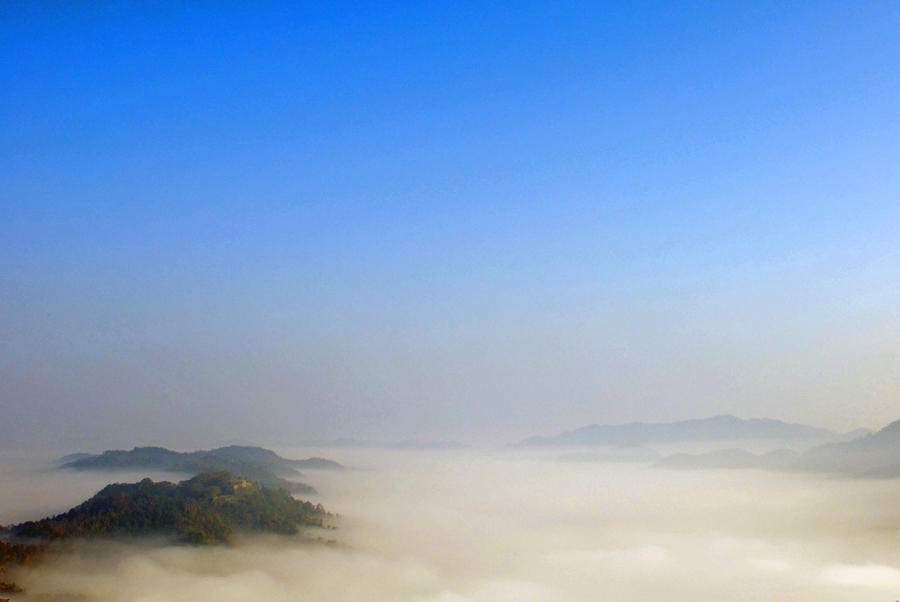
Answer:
9 472 330 544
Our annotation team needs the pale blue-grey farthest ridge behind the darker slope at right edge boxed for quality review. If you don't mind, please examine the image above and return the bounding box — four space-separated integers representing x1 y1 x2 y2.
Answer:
514 414 856 447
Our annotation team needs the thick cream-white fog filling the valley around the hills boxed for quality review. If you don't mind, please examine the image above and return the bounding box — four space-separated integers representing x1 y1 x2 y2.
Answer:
0 449 900 602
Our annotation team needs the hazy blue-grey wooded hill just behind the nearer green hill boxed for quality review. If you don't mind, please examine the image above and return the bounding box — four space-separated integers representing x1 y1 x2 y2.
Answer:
61 445 343 494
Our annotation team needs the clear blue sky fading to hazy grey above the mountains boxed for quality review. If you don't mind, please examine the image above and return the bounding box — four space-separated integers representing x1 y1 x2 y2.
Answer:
0 1 900 447
